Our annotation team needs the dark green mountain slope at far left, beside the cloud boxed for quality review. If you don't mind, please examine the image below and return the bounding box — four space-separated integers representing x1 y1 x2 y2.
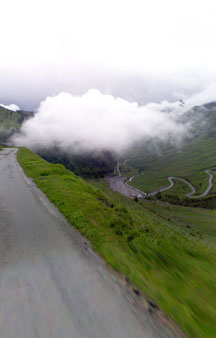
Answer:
0 106 33 143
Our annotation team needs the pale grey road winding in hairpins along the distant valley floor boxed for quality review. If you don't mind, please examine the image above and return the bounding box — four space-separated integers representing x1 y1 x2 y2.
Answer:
108 162 214 198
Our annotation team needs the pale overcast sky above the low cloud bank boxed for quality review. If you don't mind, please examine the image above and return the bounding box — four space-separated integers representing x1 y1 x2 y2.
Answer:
0 0 216 109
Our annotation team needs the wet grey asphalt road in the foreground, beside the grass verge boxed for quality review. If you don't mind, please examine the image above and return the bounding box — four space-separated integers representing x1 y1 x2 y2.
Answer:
0 149 182 338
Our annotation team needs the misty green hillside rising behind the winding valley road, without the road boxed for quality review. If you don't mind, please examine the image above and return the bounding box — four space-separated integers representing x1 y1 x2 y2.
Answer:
122 102 216 206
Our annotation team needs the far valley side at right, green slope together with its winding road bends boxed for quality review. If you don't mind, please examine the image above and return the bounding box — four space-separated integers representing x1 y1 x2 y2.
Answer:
115 103 216 209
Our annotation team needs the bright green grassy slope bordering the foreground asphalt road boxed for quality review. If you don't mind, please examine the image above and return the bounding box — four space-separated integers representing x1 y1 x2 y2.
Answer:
17 148 216 338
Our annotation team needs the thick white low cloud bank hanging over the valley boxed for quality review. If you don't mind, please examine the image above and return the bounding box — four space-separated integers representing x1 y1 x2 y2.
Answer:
13 89 203 153
